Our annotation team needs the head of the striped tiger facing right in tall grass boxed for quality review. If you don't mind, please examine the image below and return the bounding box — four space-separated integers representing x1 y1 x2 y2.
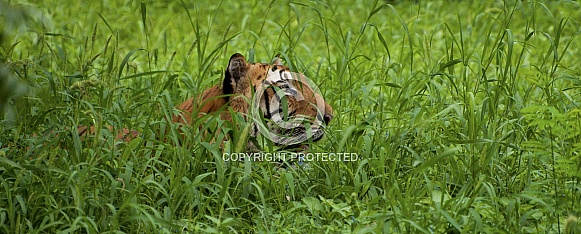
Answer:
222 53 333 146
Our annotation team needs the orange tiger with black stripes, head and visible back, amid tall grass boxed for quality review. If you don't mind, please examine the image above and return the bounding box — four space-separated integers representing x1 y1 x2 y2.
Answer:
172 53 333 149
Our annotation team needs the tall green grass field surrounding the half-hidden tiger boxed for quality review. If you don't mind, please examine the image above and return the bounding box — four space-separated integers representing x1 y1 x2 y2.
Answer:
0 0 581 233
